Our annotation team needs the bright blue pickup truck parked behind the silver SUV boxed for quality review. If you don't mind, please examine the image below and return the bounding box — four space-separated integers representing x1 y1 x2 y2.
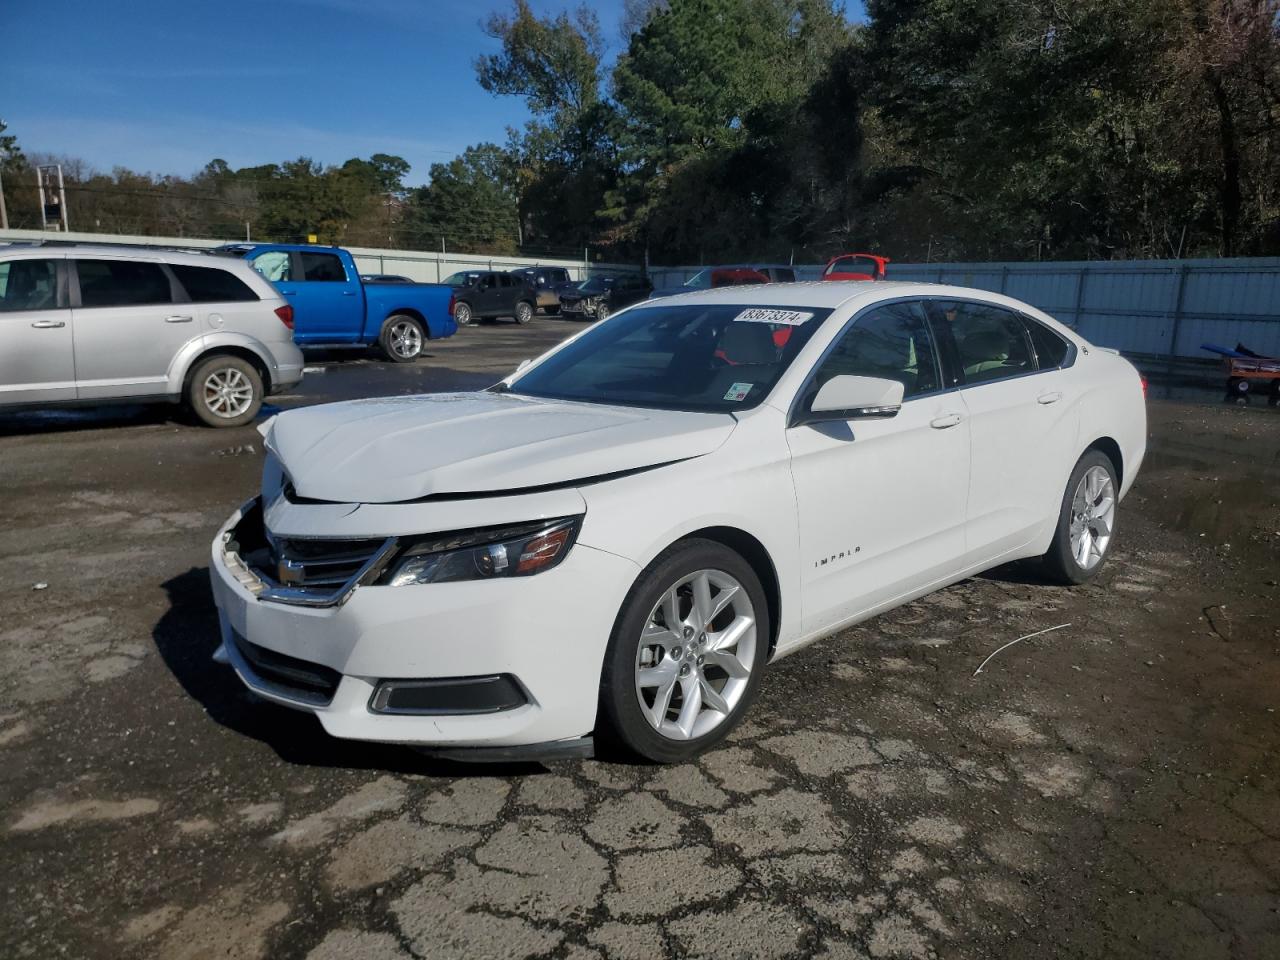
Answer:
215 243 458 364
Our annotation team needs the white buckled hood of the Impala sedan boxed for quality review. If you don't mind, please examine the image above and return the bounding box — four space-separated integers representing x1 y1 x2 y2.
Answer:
266 392 737 503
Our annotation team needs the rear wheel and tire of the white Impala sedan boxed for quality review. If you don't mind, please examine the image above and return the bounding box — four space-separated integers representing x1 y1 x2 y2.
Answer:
1042 451 1120 585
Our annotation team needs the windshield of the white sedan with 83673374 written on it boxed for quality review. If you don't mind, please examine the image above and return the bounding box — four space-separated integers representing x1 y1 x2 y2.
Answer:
511 302 831 413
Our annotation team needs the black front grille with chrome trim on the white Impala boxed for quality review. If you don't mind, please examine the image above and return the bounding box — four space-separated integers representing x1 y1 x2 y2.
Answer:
227 500 394 607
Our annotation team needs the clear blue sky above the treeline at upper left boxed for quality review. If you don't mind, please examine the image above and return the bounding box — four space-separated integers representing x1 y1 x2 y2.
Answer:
0 0 861 183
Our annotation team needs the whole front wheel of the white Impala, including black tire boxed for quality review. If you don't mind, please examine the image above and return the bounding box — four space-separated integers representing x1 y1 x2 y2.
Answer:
600 540 771 763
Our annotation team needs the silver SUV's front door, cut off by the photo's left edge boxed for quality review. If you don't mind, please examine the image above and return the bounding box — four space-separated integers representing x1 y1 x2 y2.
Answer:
0 257 76 403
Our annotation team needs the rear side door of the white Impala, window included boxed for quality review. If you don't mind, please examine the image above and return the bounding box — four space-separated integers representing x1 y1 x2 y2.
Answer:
931 301 1078 563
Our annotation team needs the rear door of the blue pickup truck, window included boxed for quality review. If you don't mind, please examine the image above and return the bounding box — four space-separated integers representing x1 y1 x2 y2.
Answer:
276 250 365 343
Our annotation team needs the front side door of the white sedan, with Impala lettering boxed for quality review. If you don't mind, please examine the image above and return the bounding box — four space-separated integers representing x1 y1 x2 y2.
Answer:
787 301 969 634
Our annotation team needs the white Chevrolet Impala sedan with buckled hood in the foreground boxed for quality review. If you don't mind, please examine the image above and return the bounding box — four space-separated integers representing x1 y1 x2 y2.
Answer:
212 283 1146 762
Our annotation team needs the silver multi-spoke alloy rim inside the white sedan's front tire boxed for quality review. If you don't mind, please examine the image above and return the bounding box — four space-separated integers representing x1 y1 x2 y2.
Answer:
635 570 756 740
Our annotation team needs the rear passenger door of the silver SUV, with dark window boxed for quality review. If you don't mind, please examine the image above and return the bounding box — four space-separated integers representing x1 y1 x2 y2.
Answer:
68 256 201 399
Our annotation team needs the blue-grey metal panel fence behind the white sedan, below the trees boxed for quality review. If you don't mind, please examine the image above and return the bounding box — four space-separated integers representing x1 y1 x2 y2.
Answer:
650 257 1280 358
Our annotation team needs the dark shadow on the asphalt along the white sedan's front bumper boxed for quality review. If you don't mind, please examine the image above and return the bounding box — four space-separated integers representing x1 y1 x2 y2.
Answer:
151 567 547 778
